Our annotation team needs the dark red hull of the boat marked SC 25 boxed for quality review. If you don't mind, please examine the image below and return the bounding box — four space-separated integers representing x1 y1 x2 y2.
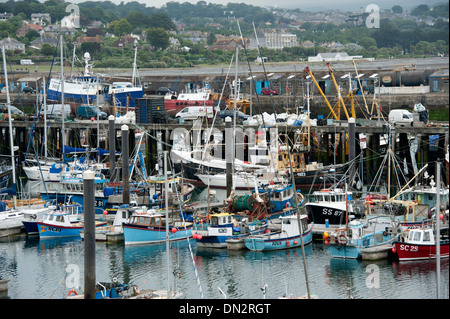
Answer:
394 241 449 260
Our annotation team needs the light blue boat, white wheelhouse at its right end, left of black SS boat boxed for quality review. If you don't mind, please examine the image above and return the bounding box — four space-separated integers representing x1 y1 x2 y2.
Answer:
244 215 313 251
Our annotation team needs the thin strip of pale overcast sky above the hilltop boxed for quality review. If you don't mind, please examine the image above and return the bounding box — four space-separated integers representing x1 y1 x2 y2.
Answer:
91 0 442 12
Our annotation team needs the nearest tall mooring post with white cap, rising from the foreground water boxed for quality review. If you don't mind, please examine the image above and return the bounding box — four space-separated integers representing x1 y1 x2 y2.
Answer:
83 170 95 299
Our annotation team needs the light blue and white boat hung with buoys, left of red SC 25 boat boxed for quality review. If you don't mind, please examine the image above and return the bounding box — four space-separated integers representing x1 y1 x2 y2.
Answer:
324 215 400 259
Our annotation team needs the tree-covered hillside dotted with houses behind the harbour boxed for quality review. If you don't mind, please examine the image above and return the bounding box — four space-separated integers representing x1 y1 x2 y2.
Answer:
0 0 449 68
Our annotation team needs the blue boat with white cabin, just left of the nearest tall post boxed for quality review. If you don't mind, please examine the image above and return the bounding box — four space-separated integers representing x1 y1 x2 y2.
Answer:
37 211 106 239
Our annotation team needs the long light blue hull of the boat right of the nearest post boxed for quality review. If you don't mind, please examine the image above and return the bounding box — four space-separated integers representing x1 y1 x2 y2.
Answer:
123 224 193 245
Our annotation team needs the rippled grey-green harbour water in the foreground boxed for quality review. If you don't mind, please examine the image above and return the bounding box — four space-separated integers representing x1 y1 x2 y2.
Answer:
0 189 449 299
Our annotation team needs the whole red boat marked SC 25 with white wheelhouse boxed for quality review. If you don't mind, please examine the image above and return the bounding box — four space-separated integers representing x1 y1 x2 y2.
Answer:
392 225 449 261
